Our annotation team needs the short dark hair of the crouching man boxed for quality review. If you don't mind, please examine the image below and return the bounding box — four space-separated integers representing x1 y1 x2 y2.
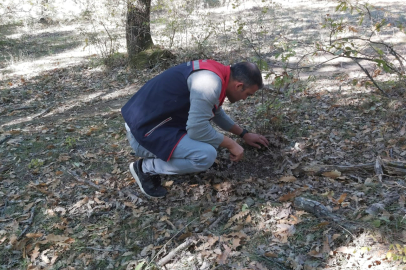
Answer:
230 62 264 89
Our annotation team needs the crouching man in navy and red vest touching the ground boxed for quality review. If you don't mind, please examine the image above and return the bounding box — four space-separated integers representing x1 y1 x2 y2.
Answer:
121 60 269 198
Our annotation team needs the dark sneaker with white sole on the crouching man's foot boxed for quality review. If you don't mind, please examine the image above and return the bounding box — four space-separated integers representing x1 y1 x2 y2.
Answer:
130 159 168 198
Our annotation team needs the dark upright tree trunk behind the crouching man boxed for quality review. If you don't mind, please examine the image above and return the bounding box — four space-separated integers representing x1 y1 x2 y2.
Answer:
126 0 153 59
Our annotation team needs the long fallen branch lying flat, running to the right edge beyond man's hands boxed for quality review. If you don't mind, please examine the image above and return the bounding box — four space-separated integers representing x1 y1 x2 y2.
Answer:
294 157 406 179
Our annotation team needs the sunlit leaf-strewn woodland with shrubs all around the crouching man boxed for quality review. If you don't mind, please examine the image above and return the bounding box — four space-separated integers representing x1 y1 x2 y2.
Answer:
0 0 406 270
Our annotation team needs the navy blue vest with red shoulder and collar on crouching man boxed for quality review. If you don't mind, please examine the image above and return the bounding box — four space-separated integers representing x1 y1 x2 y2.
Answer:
121 60 230 161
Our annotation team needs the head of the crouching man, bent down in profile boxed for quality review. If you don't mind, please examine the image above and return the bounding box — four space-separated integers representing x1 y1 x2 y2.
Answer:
226 62 263 103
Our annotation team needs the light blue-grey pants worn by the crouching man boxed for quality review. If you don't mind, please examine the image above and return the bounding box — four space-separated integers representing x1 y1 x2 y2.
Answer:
125 124 217 174
